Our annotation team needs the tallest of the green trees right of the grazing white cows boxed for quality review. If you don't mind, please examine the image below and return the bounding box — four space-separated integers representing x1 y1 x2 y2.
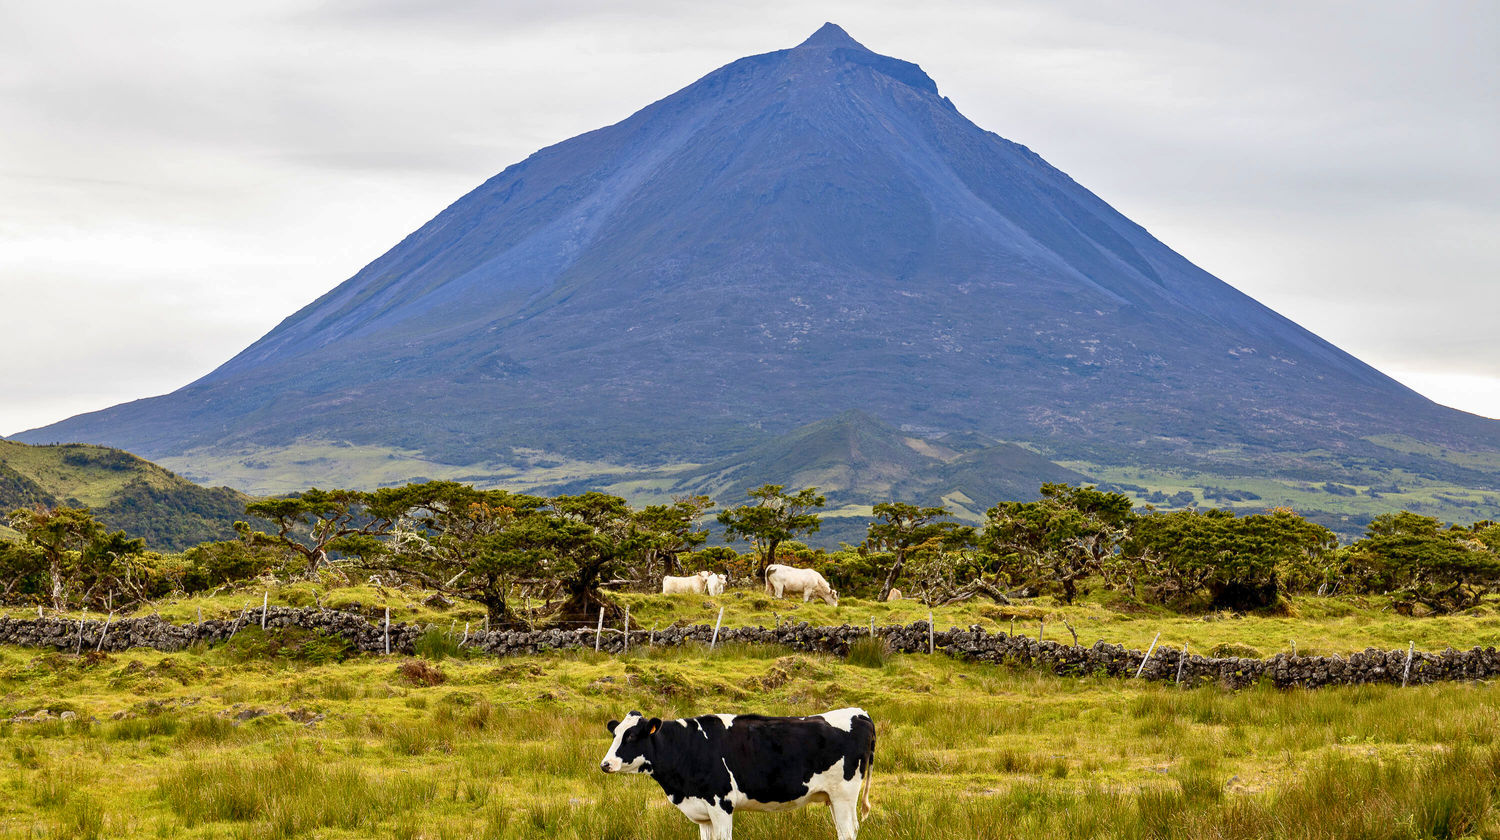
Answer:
981 483 1134 603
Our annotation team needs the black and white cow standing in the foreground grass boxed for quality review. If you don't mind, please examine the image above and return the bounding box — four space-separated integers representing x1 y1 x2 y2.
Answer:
599 708 875 840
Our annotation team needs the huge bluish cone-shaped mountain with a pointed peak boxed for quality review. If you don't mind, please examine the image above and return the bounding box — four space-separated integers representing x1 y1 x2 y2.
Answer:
17 24 1500 525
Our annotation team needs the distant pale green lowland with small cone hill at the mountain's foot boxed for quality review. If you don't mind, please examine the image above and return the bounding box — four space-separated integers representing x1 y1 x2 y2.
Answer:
146 423 1500 548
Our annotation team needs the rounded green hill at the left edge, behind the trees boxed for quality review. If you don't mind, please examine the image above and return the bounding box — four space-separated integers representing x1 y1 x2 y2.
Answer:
0 441 249 551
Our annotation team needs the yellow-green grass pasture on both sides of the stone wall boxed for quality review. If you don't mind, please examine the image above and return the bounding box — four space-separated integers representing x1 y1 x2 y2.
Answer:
0 584 1500 840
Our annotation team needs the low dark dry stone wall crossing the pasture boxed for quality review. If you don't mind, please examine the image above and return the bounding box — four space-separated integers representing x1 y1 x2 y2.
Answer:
0 606 1500 689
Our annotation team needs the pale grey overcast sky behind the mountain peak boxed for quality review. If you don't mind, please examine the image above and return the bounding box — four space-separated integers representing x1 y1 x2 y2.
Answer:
0 0 1500 434
